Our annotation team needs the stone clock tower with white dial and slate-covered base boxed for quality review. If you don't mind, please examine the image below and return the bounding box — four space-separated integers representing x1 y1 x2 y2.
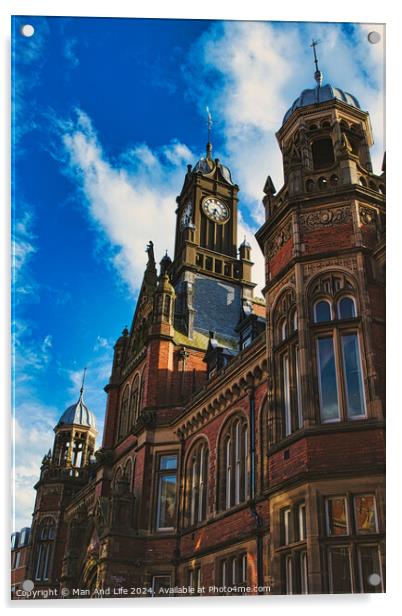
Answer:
171 137 255 347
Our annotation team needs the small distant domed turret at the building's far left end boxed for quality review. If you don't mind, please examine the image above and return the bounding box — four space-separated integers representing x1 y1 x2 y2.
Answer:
28 386 97 588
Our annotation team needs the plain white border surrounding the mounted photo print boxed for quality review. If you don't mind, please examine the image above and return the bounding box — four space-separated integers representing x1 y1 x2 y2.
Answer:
0 0 402 616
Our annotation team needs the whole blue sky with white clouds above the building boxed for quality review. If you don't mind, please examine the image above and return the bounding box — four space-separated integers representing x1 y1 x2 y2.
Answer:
12 17 384 528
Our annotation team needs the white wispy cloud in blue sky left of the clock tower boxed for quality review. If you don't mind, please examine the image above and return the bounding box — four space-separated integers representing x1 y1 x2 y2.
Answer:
59 111 194 293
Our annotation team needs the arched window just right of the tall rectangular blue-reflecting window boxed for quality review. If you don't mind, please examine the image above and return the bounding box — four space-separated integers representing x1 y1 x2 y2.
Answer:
185 440 209 526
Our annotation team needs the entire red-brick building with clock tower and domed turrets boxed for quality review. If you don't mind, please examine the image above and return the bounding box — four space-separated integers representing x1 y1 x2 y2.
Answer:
17 71 385 597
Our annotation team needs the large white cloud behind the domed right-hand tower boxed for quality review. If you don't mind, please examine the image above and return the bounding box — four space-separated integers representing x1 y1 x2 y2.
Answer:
183 21 384 224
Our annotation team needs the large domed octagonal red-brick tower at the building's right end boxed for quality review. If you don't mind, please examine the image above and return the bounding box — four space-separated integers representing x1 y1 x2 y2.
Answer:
256 41 385 593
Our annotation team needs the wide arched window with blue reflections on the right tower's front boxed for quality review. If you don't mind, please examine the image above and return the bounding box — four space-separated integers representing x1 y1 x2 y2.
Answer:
311 273 366 423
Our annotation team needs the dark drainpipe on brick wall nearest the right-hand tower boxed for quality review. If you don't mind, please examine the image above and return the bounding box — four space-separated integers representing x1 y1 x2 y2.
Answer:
247 383 264 595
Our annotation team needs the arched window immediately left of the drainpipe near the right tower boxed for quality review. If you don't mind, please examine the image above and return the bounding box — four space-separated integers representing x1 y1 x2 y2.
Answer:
219 415 249 509
